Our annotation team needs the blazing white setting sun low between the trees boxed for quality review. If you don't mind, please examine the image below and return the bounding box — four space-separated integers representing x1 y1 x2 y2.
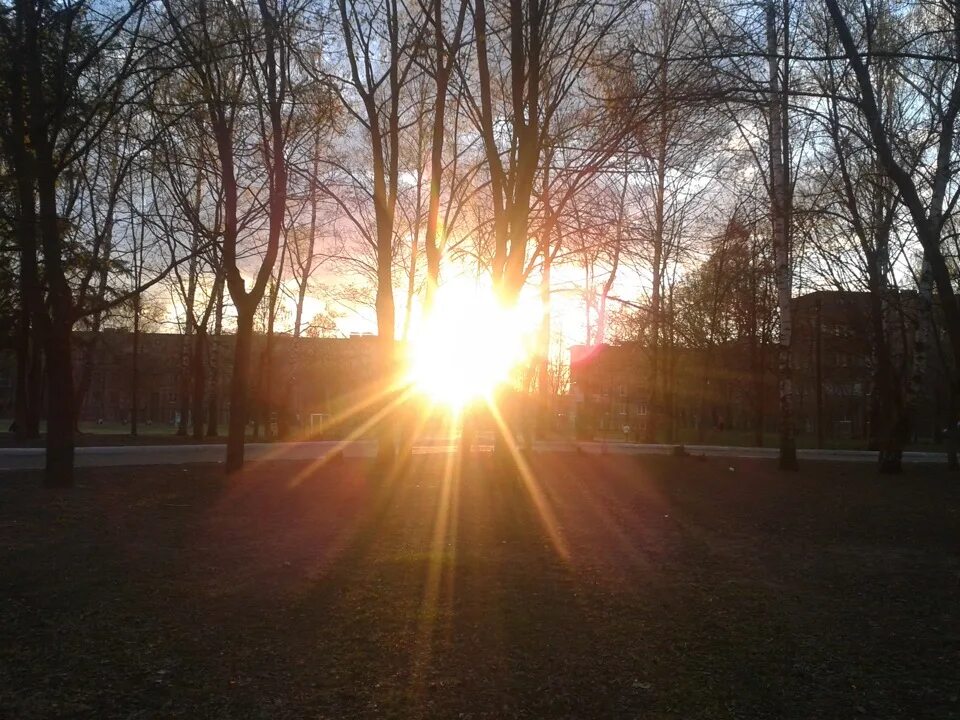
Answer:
407 281 530 412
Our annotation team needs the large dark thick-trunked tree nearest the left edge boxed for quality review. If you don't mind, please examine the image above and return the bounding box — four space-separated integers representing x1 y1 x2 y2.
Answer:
0 0 191 485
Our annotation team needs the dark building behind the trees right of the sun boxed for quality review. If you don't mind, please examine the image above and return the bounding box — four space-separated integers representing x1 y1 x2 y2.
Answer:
570 291 949 446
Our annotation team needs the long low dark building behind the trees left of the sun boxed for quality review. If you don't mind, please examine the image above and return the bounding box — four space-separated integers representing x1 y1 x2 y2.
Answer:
0 329 386 428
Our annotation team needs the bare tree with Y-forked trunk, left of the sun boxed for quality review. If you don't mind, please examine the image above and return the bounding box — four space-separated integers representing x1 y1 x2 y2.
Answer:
164 0 303 473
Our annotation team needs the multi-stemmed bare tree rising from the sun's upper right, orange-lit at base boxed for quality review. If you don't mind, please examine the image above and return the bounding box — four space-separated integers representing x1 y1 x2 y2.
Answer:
464 0 630 303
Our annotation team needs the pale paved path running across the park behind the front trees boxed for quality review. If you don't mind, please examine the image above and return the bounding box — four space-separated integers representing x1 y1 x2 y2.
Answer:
0 438 946 470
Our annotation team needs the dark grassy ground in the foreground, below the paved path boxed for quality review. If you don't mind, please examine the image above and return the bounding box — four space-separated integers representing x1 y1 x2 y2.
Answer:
0 454 960 720
